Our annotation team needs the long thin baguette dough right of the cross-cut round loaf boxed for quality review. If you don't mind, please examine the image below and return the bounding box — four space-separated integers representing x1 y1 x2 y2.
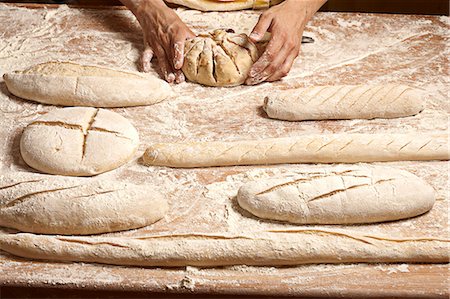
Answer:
143 134 450 167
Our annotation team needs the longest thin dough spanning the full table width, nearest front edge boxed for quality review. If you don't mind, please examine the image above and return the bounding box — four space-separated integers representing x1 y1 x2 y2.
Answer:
0 228 450 267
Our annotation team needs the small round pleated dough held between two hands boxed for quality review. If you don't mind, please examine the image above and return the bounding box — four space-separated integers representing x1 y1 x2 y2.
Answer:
182 30 258 86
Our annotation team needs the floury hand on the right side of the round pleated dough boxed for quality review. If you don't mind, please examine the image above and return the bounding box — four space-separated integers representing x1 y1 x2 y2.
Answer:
245 0 326 85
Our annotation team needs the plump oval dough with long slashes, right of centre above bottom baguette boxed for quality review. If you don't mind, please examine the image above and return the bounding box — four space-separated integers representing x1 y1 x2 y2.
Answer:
237 167 435 224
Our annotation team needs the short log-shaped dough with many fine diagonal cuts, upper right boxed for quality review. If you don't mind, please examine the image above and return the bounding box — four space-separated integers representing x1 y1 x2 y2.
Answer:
263 84 424 121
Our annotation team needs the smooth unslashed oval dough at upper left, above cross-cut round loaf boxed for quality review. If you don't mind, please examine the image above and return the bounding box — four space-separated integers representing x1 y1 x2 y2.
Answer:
3 62 171 107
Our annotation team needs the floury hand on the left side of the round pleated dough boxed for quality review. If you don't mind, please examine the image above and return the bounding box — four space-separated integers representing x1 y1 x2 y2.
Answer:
122 0 195 83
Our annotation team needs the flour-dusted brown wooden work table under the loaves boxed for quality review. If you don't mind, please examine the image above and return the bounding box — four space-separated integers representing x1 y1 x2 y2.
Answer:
0 4 450 297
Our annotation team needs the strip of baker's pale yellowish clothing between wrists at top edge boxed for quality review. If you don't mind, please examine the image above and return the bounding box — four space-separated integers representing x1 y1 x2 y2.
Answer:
166 0 284 11
